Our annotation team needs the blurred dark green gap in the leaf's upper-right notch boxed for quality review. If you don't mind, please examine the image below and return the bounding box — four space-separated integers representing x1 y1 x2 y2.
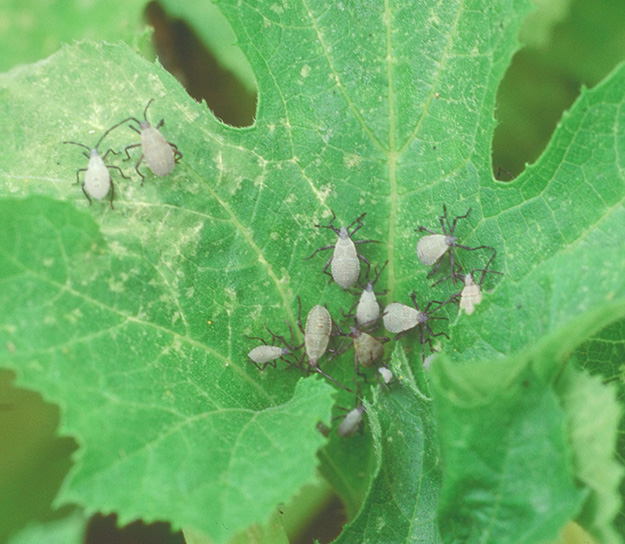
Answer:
492 0 625 181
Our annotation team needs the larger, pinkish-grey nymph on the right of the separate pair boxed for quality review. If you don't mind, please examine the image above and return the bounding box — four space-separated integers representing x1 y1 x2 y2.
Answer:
124 98 182 185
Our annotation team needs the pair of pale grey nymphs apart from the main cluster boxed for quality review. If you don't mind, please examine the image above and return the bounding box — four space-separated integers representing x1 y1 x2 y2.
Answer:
63 98 182 208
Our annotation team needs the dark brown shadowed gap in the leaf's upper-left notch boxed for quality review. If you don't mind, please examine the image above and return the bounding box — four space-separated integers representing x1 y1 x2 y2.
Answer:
145 2 256 127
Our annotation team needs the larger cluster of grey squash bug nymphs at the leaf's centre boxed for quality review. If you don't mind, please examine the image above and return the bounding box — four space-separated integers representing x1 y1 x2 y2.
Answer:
248 206 501 436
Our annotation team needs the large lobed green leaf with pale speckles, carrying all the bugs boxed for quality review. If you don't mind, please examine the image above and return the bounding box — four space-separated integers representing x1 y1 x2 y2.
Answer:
0 0 625 542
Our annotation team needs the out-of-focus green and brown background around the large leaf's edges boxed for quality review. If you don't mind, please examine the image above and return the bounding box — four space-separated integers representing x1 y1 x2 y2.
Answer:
0 0 625 544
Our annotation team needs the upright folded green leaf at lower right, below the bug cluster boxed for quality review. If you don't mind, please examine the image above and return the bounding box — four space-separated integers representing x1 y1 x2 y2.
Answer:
433 357 584 543
